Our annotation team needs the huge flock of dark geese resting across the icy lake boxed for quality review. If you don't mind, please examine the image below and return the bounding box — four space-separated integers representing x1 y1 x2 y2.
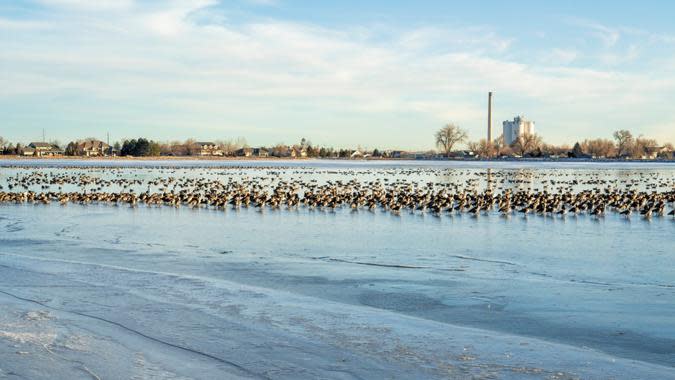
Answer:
0 167 675 219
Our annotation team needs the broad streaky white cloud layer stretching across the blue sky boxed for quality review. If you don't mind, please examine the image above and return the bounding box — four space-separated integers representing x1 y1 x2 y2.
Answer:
0 4 675 144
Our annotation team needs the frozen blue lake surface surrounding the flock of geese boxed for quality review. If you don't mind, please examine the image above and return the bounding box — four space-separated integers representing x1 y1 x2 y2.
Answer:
0 160 675 379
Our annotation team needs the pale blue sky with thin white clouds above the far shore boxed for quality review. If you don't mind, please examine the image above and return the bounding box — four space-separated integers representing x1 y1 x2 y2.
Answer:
0 0 675 150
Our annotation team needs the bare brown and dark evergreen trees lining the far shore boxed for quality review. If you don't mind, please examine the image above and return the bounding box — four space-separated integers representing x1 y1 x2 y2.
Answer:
0 130 673 158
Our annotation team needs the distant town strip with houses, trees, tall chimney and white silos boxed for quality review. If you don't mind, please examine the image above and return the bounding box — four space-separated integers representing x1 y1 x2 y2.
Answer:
0 106 674 160
